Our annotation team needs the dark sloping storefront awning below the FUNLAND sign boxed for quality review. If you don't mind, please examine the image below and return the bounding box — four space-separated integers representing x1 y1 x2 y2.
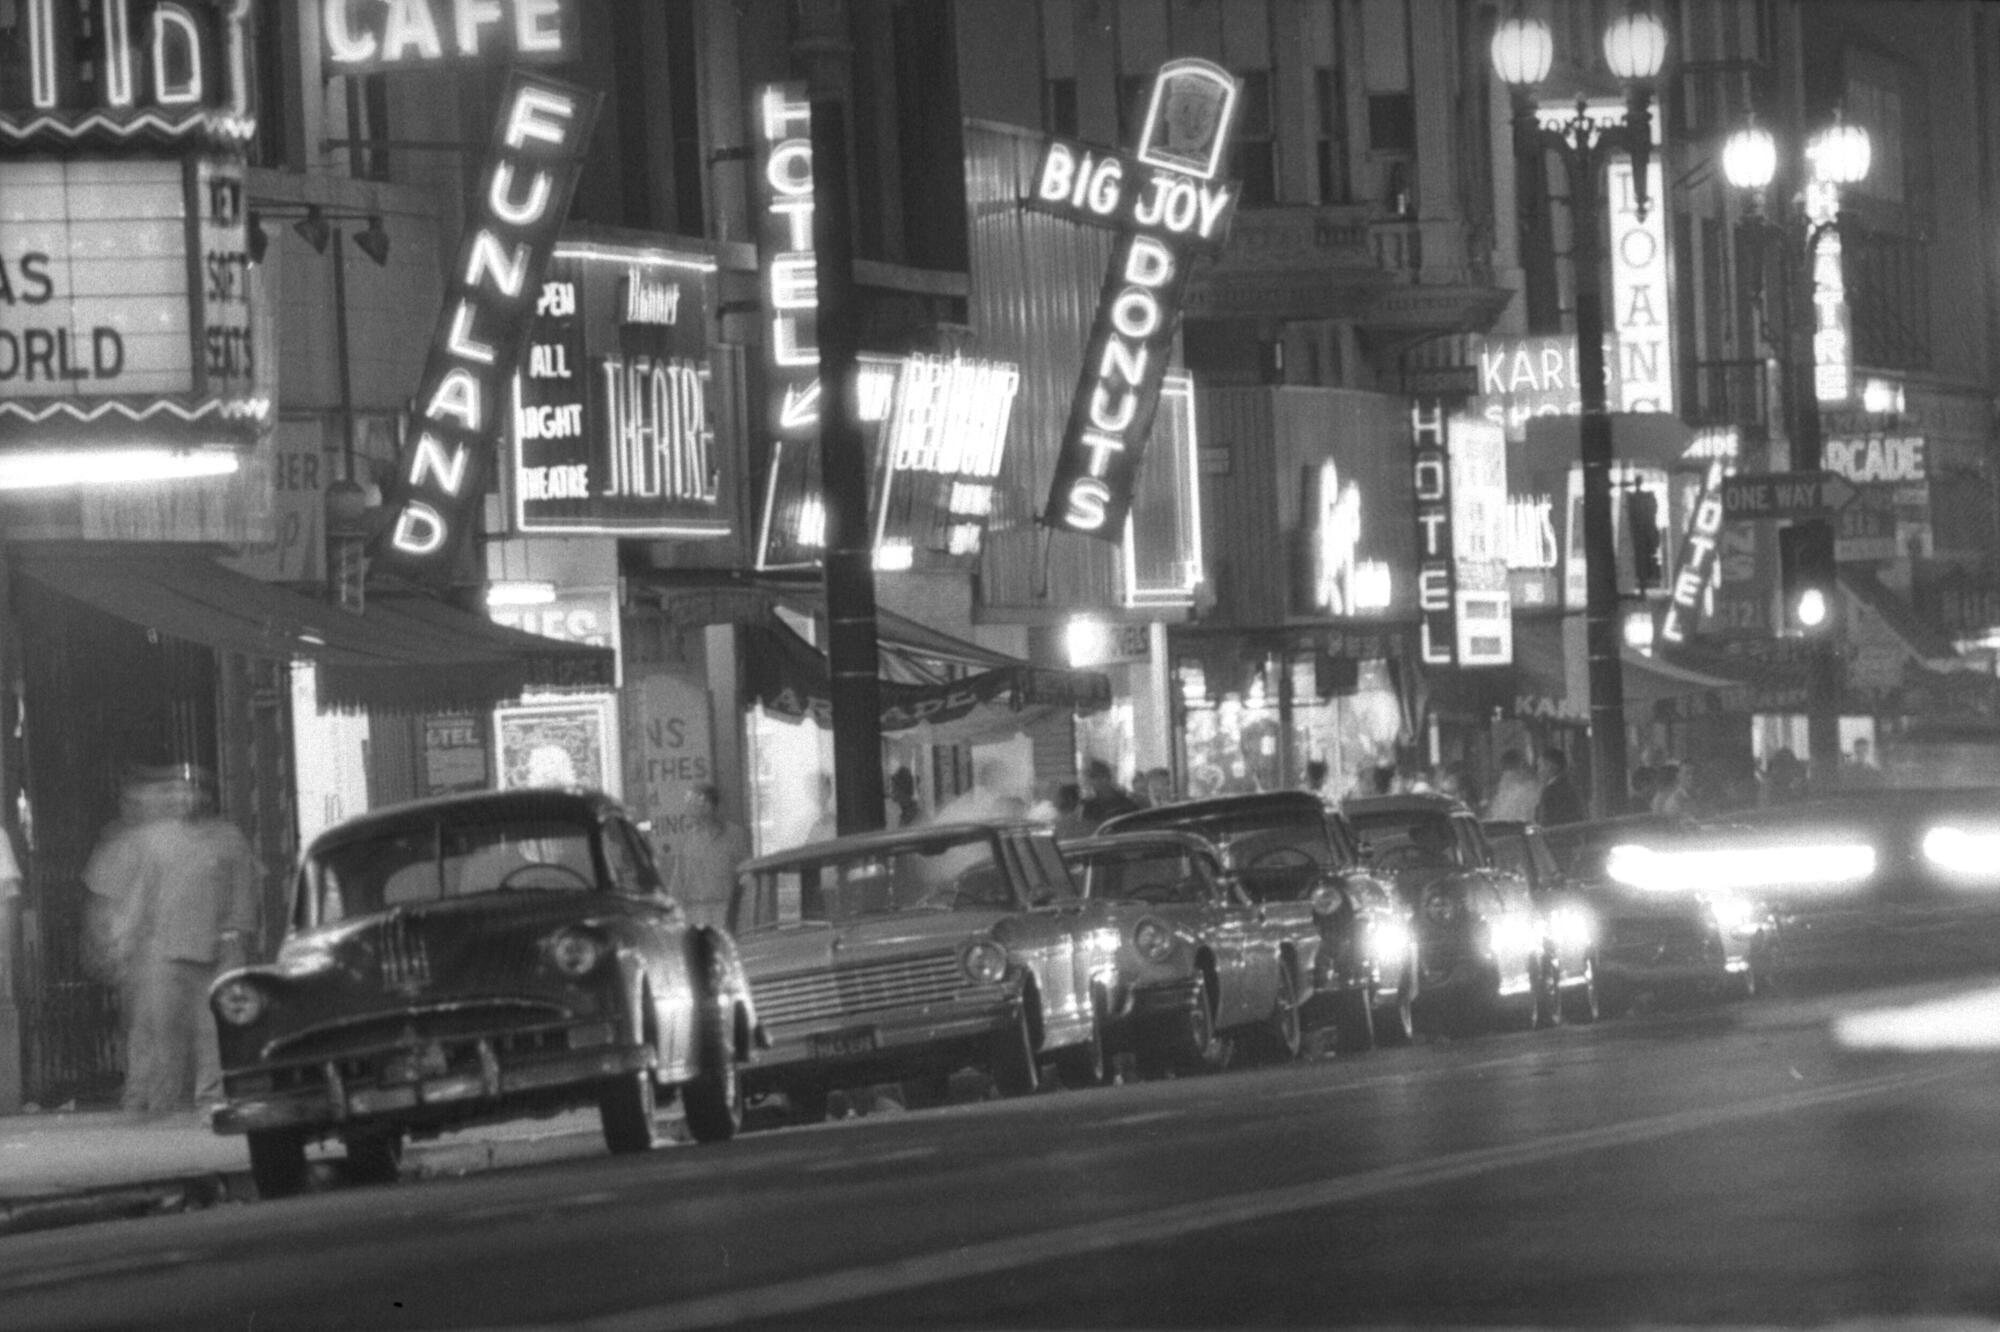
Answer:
12 542 616 712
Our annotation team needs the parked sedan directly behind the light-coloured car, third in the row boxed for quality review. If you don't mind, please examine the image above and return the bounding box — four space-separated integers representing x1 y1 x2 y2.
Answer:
1062 828 1360 1076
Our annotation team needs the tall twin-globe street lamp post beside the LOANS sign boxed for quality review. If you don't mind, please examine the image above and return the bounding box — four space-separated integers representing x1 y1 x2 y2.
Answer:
1492 10 1666 818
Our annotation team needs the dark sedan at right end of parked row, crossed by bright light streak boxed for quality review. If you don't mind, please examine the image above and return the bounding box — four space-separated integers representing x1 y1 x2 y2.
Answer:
1542 814 1780 1012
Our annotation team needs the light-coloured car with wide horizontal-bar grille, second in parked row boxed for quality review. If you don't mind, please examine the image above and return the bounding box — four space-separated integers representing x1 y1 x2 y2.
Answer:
730 822 1166 1122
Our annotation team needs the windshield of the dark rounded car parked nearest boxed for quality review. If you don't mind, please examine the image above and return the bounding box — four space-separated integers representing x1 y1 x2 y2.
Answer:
304 818 602 924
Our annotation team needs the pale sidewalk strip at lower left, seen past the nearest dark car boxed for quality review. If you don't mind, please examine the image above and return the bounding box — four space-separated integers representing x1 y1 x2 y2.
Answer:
0 1110 612 1236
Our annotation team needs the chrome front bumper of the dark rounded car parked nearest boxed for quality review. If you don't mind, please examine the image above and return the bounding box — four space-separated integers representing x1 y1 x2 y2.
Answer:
210 1028 652 1134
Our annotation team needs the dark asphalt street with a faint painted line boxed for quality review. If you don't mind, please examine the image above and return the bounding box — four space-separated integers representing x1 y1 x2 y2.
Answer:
0 980 2000 1332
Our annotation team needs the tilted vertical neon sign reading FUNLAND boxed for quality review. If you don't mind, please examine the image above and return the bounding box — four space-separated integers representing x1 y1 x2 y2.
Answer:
376 72 602 584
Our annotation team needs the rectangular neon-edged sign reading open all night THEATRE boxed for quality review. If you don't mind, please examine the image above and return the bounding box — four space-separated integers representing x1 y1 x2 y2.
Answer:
512 240 738 538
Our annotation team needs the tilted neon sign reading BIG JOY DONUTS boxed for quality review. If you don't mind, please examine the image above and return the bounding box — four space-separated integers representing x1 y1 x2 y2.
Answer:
1028 60 1238 542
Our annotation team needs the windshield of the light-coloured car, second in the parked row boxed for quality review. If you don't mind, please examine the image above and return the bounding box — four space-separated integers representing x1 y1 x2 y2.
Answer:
730 828 1026 934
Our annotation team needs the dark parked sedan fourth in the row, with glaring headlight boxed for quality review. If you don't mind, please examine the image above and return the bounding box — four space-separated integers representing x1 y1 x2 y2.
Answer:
1098 790 1416 1054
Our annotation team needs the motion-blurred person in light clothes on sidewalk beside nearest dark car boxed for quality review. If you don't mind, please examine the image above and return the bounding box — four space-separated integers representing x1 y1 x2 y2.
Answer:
98 768 258 1116
